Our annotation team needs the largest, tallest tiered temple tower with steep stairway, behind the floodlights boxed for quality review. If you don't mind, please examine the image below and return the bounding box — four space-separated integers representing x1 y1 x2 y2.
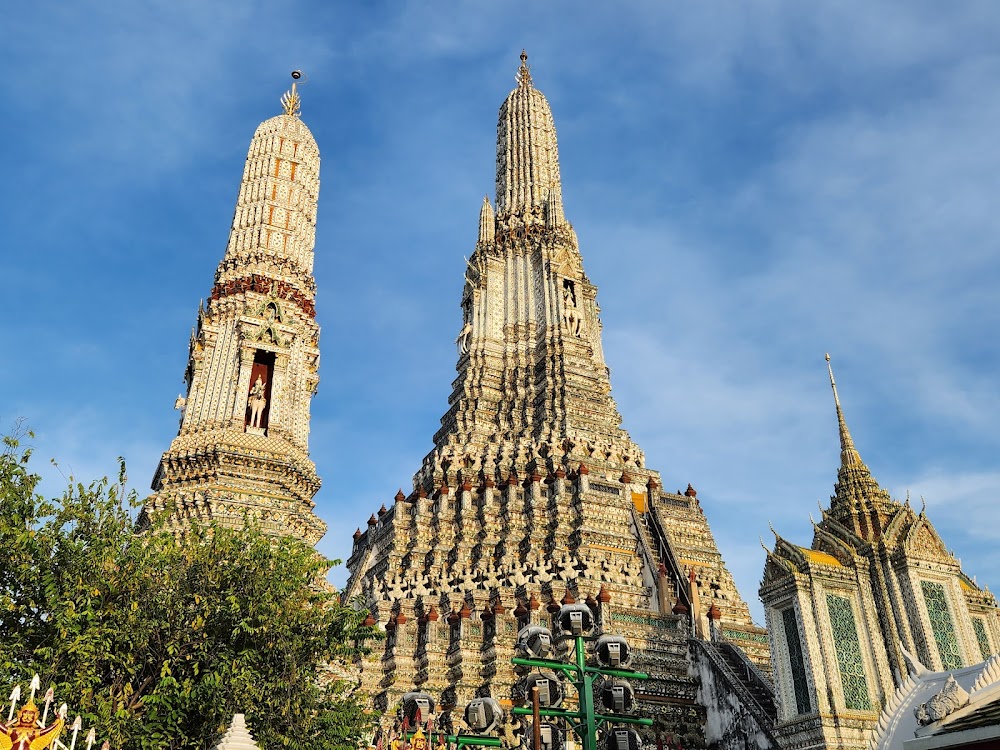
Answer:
345 54 767 734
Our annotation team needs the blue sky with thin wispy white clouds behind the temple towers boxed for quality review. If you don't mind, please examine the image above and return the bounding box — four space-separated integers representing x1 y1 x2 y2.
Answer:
0 0 1000 617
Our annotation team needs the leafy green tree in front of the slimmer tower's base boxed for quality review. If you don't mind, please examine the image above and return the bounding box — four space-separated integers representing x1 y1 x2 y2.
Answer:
0 437 377 749
